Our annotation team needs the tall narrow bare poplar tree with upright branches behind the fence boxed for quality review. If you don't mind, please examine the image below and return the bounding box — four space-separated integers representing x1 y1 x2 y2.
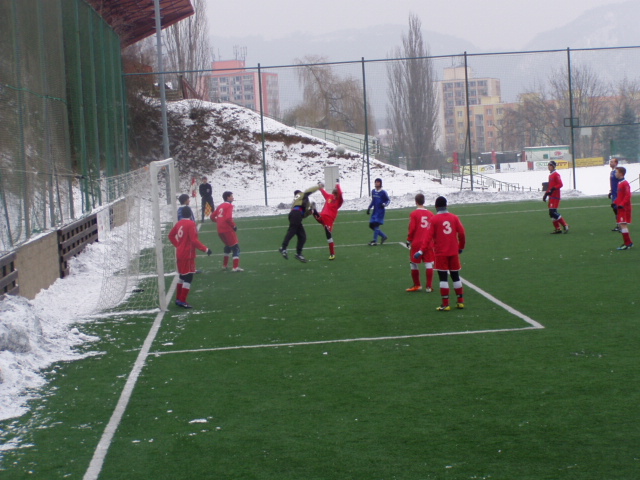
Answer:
387 14 439 170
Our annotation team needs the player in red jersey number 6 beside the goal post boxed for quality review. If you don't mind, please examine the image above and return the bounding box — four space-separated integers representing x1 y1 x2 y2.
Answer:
169 206 211 308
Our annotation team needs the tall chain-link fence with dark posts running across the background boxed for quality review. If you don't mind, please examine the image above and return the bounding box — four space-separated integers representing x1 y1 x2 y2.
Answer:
142 46 640 202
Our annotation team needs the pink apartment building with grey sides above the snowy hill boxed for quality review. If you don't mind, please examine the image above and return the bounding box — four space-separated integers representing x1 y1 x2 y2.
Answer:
203 60 280 118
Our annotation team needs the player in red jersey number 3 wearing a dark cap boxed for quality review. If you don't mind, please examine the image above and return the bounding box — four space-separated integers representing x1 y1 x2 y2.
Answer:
413 197 467 312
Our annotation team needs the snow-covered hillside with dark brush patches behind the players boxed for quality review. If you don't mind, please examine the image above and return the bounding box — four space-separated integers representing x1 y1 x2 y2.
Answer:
164 100 552 215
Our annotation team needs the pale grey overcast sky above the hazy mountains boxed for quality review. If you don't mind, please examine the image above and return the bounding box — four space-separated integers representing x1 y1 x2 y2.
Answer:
206 0 623 49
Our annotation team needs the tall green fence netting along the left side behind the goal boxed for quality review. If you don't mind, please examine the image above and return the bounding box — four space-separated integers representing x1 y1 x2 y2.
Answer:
0 0 128 251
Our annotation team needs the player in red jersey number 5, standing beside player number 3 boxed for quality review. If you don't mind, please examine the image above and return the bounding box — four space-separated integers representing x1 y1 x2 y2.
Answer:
407 193 435 293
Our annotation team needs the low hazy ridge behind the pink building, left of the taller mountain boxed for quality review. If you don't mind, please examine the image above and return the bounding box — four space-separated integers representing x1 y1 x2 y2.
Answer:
212 25 478 67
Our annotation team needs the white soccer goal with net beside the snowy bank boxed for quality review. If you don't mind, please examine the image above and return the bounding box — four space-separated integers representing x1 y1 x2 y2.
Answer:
97 158 177 312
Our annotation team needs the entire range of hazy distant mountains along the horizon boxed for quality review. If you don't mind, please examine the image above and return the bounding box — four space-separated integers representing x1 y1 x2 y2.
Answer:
212 0 640 67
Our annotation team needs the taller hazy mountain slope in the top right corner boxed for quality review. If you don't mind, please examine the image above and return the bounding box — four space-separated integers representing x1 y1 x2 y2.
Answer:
525 0 640 50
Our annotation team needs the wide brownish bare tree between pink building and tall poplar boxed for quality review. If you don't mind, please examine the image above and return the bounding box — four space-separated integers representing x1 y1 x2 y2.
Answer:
286 55 374 134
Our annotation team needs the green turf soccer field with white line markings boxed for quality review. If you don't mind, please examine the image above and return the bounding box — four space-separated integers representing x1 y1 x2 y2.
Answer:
0 198 640 480
